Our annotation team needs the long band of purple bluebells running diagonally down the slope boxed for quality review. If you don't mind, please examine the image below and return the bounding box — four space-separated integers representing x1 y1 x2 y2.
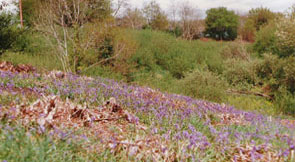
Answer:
0 72 295 161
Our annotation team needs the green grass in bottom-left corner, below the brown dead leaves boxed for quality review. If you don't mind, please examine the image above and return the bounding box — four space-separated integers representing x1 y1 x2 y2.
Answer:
0 123 118 162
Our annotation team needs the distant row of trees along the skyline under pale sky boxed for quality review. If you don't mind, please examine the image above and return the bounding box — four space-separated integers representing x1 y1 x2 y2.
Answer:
1 0 290 53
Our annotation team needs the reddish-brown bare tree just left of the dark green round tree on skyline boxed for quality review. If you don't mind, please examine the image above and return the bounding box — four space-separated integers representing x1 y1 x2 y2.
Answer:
179 1 203 40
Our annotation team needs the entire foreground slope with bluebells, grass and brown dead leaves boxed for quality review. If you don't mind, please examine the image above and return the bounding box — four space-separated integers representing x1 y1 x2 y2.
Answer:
0 62 295 161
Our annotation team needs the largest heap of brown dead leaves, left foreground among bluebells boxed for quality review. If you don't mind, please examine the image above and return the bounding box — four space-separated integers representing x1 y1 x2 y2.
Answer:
0 96 174 161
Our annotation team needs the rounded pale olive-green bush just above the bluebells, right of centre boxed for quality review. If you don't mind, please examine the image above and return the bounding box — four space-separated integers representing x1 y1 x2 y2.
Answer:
179 70 227 102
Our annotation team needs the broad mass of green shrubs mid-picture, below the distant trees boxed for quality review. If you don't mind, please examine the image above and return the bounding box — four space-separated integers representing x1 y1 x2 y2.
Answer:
131 30 225 79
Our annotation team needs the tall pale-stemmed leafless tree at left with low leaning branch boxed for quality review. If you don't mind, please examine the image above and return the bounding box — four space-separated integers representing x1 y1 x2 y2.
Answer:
35 0 123 72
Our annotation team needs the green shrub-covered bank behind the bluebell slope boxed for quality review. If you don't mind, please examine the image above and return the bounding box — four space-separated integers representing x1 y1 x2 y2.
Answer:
0 29 295 116
